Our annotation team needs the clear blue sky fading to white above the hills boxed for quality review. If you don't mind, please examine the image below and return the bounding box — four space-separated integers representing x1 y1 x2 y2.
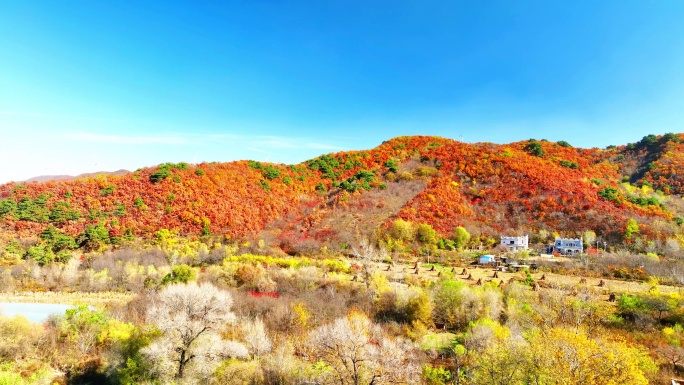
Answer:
0 0 684 182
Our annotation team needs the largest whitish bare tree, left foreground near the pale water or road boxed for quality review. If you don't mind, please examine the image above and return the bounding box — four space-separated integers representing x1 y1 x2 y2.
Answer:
143 283 247 379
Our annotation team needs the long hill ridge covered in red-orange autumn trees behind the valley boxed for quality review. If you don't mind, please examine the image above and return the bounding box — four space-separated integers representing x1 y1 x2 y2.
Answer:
0 134 684 253
